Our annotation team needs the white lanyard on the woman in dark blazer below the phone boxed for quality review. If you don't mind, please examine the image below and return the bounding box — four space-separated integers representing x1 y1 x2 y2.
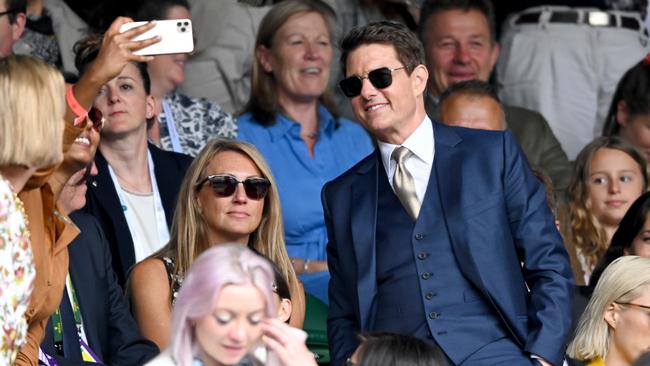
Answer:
108 150 169 261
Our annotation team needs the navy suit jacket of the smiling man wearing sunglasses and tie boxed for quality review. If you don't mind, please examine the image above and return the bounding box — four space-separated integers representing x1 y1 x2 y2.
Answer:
322 123 573 366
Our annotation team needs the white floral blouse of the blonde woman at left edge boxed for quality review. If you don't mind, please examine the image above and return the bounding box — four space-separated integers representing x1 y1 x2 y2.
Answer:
0 176 36 365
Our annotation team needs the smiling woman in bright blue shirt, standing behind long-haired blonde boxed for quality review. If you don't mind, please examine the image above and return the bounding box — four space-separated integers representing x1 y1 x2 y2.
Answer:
237 0 373 302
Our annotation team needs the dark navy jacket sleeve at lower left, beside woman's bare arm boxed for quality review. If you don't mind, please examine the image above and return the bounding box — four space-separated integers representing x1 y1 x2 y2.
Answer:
93 220 159 365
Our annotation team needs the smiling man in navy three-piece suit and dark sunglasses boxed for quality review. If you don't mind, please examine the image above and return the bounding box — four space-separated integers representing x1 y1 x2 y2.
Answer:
322 22 573 366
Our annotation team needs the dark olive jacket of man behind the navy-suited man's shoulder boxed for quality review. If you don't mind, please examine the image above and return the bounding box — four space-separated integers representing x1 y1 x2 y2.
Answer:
425 97 572 195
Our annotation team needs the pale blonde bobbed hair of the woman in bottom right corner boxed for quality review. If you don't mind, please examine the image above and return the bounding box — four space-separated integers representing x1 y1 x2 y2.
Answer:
567 256 650 360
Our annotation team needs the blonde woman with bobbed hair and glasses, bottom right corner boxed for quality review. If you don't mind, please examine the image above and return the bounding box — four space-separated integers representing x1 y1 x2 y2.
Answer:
567 256 650 366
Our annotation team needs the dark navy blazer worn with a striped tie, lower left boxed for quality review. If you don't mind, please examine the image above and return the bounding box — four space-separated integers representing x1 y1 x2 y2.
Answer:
41 212 159 366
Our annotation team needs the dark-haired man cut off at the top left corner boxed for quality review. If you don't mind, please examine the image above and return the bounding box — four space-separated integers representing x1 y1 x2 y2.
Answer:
0 0 27 57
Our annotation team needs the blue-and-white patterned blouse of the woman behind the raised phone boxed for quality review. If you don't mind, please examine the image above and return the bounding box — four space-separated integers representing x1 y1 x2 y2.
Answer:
158 93 237 156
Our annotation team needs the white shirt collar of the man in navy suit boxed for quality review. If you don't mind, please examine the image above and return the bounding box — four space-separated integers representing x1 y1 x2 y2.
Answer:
377 116 435 172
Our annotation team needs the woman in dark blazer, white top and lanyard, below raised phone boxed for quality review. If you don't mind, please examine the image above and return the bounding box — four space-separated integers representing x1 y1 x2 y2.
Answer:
76 38 192 286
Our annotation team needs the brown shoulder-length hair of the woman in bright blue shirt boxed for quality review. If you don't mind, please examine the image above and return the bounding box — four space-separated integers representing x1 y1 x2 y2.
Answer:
244 0 337 125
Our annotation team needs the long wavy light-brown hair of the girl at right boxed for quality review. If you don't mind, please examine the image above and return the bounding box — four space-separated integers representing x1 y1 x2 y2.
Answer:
561 136 648 268
